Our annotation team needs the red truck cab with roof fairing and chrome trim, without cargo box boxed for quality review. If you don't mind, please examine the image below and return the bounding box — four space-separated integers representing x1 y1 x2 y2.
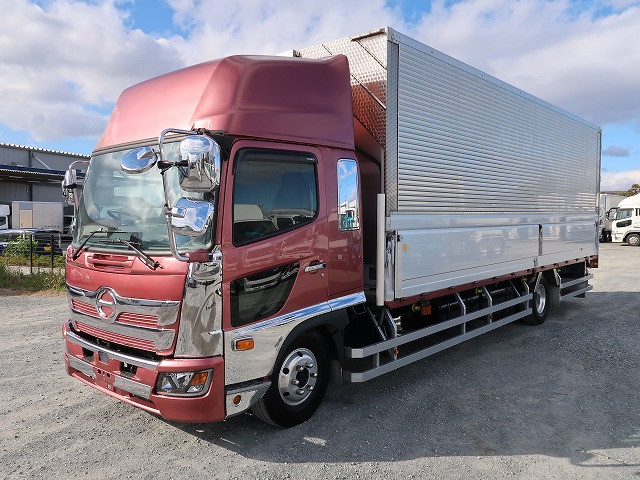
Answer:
63 56 370 424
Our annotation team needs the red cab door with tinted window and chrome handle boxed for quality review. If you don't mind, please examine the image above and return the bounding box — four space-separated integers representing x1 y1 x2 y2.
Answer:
222 141 328 329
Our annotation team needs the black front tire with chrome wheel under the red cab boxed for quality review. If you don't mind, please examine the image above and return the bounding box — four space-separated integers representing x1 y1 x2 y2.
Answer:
251 333 331 428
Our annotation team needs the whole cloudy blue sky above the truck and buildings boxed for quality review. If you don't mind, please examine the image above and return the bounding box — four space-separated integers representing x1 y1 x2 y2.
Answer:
0 0 640 190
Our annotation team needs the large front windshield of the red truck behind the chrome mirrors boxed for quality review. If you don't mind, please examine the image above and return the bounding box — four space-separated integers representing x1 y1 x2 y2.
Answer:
73 142 213 251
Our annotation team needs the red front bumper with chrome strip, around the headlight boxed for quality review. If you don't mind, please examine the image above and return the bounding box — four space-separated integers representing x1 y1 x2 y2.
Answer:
62 323 225 422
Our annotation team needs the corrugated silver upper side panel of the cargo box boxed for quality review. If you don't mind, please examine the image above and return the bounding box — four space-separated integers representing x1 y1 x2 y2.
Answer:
397 31 600 214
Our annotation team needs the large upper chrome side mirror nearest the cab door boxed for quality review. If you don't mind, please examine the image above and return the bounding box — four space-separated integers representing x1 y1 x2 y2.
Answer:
179 135 221 192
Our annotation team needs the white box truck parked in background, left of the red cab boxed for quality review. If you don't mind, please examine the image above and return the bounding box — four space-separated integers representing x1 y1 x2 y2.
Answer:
0 201 63 232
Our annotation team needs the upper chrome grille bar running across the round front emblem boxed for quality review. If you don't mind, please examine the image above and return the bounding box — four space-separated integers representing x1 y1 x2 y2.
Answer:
67 283 180 326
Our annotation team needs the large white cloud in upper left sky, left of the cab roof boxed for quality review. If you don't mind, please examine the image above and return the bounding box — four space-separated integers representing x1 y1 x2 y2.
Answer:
0 0 183 141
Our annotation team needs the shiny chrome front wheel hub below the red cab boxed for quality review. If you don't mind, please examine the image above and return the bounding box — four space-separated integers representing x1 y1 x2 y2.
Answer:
278 348 318 405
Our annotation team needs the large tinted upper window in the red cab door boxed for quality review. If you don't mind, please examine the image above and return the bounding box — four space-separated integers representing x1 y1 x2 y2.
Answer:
233 149 318 246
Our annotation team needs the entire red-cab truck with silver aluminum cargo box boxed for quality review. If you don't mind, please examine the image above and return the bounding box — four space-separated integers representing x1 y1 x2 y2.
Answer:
63 28 601 427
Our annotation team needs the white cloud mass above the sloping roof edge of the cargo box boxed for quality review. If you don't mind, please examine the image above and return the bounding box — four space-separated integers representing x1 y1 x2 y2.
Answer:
408 0 640 124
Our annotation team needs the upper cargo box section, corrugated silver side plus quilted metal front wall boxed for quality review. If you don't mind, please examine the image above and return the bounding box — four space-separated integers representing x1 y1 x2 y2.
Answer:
301 28 600 215
